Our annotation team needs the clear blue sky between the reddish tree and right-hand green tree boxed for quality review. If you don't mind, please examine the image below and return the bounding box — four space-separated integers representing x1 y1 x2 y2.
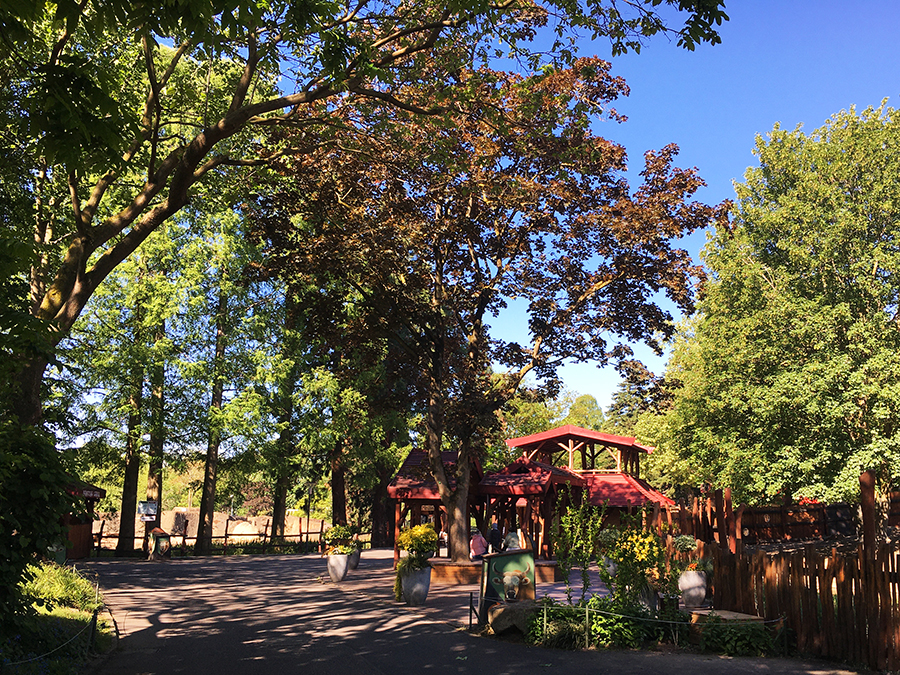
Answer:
524 0 900 407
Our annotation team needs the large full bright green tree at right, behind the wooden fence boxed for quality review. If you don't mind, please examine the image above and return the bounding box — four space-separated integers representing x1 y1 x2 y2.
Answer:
667 105 900 503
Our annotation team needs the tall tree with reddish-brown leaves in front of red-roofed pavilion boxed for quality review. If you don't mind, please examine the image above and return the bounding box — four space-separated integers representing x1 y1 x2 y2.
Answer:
251 59 716 556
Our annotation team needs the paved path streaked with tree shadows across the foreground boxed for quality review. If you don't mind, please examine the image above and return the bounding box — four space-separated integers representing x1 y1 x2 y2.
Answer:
81 551 855 675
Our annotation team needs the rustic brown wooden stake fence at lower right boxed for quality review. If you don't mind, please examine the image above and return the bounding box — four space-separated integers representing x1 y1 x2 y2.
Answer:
647 472 900 671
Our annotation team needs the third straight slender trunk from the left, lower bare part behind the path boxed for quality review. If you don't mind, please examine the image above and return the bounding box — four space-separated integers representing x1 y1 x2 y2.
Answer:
197 283 228 555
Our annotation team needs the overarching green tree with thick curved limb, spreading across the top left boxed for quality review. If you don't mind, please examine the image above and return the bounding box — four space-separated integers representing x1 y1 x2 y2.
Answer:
0 0 727 424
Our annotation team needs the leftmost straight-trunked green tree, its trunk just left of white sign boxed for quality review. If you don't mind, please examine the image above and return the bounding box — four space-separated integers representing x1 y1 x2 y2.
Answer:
58 222 182 554
